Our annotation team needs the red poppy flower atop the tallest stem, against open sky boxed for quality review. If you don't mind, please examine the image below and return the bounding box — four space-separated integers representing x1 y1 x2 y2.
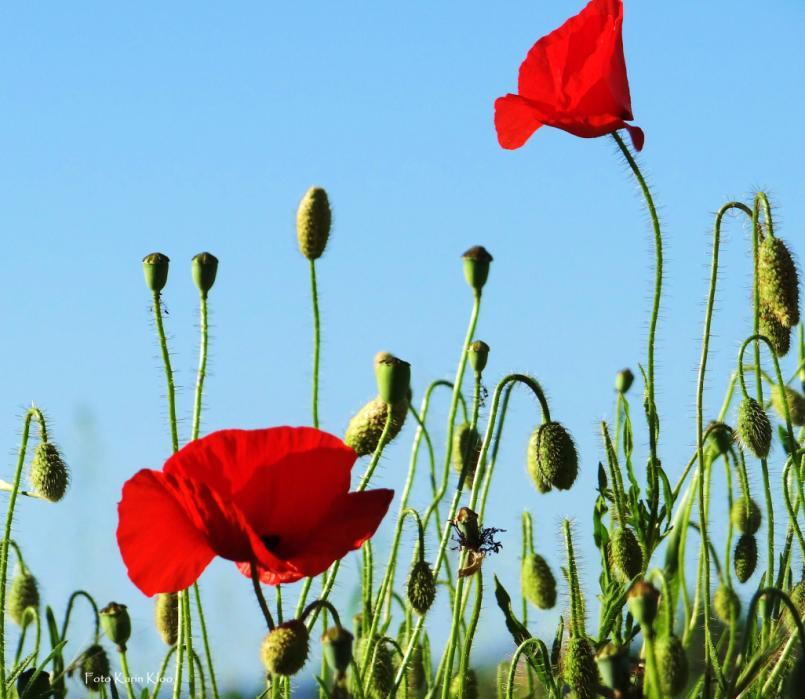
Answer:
495 0 644 150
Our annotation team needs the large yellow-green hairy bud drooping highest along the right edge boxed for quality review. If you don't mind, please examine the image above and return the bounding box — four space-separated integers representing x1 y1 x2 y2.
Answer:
758 236 799 328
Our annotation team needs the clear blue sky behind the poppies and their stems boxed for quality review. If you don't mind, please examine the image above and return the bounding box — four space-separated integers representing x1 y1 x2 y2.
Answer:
0 0 805 696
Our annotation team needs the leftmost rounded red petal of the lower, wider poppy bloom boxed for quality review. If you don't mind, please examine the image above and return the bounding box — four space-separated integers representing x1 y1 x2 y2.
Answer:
117 469 215 597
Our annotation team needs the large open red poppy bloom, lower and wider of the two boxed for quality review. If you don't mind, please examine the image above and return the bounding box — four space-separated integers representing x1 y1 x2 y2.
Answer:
117 427 394 596
